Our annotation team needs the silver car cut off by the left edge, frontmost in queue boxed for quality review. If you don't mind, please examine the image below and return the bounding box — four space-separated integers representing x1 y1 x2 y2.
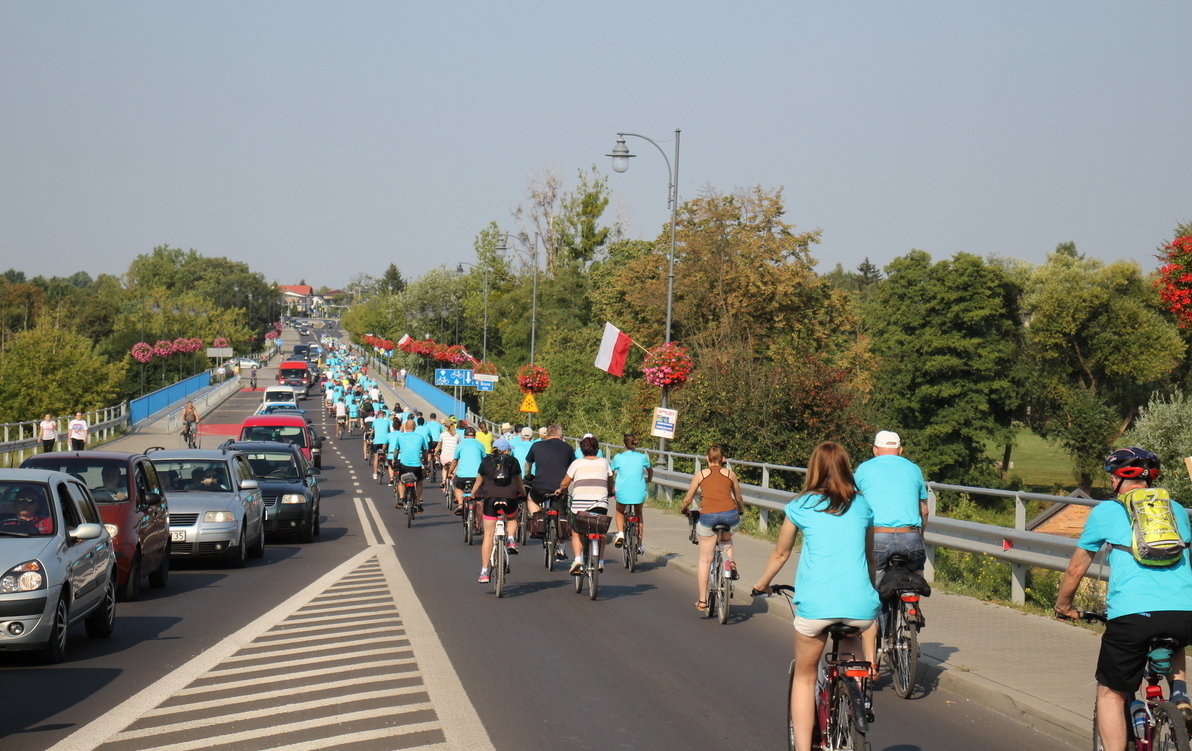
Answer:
0 470 116 663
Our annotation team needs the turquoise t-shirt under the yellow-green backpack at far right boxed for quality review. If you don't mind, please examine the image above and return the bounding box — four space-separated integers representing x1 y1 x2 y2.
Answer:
1076 491 1192 619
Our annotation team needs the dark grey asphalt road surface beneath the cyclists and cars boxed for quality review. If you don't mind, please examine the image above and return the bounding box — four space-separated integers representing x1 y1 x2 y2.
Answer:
0 331 1082 751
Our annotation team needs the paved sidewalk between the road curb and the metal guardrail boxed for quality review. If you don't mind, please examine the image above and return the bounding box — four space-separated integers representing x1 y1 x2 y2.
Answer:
644 508 1100 747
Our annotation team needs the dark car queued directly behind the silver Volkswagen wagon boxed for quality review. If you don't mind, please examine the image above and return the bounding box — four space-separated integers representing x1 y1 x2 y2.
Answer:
221 441 322 542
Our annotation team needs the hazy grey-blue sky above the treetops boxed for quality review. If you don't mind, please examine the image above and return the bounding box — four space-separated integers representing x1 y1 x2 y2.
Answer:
0 0 1192 287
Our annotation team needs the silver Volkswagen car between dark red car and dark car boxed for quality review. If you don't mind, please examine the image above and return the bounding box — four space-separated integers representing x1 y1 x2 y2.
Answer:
149 448 265 569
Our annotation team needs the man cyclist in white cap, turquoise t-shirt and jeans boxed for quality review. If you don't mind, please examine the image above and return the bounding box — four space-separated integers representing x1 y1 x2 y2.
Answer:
853 430 927 638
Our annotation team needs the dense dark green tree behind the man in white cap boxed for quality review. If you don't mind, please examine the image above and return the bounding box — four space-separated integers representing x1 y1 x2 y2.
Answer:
865 250 1023 483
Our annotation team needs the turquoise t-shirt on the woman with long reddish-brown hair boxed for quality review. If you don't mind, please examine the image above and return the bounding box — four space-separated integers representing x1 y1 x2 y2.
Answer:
786 494 879 620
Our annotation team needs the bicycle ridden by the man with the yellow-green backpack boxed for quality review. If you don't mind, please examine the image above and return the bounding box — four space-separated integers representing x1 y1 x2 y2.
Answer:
1064 612 1190 751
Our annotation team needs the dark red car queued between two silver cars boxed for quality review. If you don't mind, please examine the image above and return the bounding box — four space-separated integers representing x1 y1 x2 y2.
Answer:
20 451 169 601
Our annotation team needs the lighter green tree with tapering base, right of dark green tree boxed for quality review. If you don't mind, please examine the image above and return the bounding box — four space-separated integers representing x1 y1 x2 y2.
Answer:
1024 243 1186 489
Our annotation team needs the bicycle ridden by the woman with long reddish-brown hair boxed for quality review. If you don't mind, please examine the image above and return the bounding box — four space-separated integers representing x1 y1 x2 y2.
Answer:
752 584 874 751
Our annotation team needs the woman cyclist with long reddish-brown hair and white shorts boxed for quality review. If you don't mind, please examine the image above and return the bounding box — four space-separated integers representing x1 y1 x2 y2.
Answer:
753 441 879 751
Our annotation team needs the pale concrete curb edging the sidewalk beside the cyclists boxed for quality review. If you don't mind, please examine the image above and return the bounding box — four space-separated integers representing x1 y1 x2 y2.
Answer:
642 545 1093 749
